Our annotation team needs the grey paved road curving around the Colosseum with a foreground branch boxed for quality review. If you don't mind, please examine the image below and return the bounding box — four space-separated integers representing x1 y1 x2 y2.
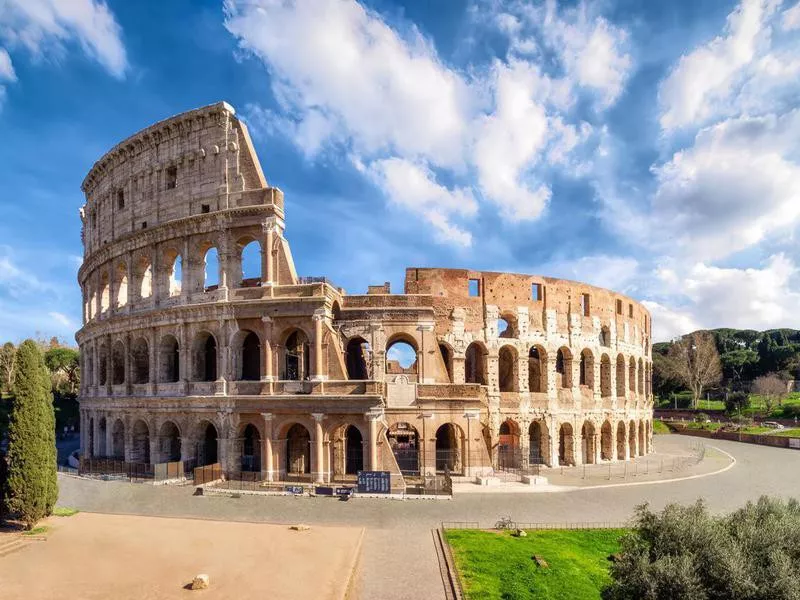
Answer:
59 436 800 599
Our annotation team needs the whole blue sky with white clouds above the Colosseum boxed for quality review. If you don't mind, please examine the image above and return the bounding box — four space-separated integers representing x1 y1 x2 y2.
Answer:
0 0 800 341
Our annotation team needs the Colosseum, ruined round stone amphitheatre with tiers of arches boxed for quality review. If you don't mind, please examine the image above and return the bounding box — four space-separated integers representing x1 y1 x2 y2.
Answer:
76 102 652 489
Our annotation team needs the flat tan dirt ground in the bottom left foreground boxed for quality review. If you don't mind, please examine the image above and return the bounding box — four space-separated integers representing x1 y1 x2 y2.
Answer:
0 513 363 600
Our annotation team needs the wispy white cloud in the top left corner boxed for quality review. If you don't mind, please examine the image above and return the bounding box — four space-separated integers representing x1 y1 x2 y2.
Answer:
0 0 128 78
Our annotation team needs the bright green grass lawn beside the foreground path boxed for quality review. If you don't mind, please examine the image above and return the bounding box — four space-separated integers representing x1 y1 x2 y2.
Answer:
445 529 625 600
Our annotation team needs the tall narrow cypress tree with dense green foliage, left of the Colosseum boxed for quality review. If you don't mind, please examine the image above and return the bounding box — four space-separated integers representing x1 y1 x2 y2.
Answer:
6 340 58 529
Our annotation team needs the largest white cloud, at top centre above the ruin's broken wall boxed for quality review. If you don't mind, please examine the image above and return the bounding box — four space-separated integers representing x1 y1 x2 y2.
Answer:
225 0 630 246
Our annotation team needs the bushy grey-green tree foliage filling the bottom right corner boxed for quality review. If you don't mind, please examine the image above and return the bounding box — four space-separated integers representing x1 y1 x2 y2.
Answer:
603 497 800 600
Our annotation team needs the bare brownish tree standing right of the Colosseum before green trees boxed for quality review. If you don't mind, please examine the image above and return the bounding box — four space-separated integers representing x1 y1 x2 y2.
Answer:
666 331 722 408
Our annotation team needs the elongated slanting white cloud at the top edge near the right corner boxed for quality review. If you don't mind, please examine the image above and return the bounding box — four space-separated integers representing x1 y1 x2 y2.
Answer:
659 0 778 131
